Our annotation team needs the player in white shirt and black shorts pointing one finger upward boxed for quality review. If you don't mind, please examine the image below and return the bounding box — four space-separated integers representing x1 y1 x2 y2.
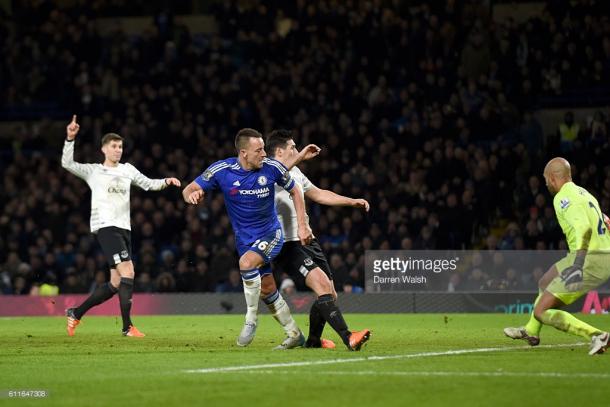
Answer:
61 115 180 337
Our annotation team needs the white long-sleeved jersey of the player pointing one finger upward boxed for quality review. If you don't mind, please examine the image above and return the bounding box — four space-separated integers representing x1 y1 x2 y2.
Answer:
61 141 167 233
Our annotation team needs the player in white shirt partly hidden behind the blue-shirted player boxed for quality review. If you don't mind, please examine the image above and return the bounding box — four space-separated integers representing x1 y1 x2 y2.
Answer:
261 130 371 351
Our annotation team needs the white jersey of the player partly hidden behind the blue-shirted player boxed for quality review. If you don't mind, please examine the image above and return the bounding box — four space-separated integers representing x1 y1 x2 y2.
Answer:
275 167 315 242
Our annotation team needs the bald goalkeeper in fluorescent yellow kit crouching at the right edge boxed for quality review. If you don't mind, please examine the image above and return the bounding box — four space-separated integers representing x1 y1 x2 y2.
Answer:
504 157 610 355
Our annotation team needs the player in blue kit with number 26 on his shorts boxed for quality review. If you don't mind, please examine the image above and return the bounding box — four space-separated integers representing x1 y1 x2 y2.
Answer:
182 128 320 349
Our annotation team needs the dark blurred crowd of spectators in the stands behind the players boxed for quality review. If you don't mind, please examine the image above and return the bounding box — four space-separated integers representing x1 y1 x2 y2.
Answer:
0 0 610 294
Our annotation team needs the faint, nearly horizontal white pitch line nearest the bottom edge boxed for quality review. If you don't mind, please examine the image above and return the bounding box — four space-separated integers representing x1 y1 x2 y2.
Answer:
223 369 610 379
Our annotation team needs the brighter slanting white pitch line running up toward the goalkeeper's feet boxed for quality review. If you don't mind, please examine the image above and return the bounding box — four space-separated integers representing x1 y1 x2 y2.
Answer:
185 342 586 373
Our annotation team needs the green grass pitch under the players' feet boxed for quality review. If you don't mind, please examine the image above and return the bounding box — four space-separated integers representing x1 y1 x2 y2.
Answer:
0 314 610 407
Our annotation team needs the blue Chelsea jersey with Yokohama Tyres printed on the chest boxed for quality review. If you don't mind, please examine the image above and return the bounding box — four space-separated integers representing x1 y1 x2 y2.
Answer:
195 157 295 244
